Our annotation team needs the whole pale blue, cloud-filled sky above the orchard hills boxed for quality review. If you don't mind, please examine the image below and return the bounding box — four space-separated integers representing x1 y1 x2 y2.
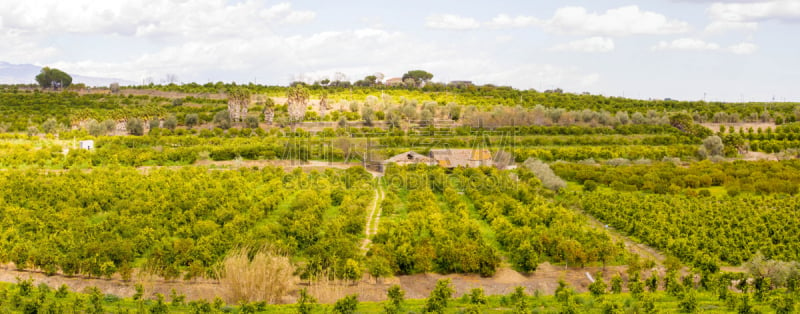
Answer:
0 0 800 101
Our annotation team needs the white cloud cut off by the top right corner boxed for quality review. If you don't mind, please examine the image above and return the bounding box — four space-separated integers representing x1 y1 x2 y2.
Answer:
708 0 800 22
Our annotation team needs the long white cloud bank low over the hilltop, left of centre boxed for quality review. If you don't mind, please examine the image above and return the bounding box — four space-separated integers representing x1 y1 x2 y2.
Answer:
44 28 438 84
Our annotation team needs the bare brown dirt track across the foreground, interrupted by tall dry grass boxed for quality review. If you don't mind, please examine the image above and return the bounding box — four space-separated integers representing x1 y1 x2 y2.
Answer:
0 262 625 304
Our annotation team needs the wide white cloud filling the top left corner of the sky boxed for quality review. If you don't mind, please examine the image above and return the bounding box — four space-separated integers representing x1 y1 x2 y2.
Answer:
0 0 316 38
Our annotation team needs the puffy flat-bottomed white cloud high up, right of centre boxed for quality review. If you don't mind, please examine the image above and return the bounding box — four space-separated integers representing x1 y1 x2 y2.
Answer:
544 5 689 36
